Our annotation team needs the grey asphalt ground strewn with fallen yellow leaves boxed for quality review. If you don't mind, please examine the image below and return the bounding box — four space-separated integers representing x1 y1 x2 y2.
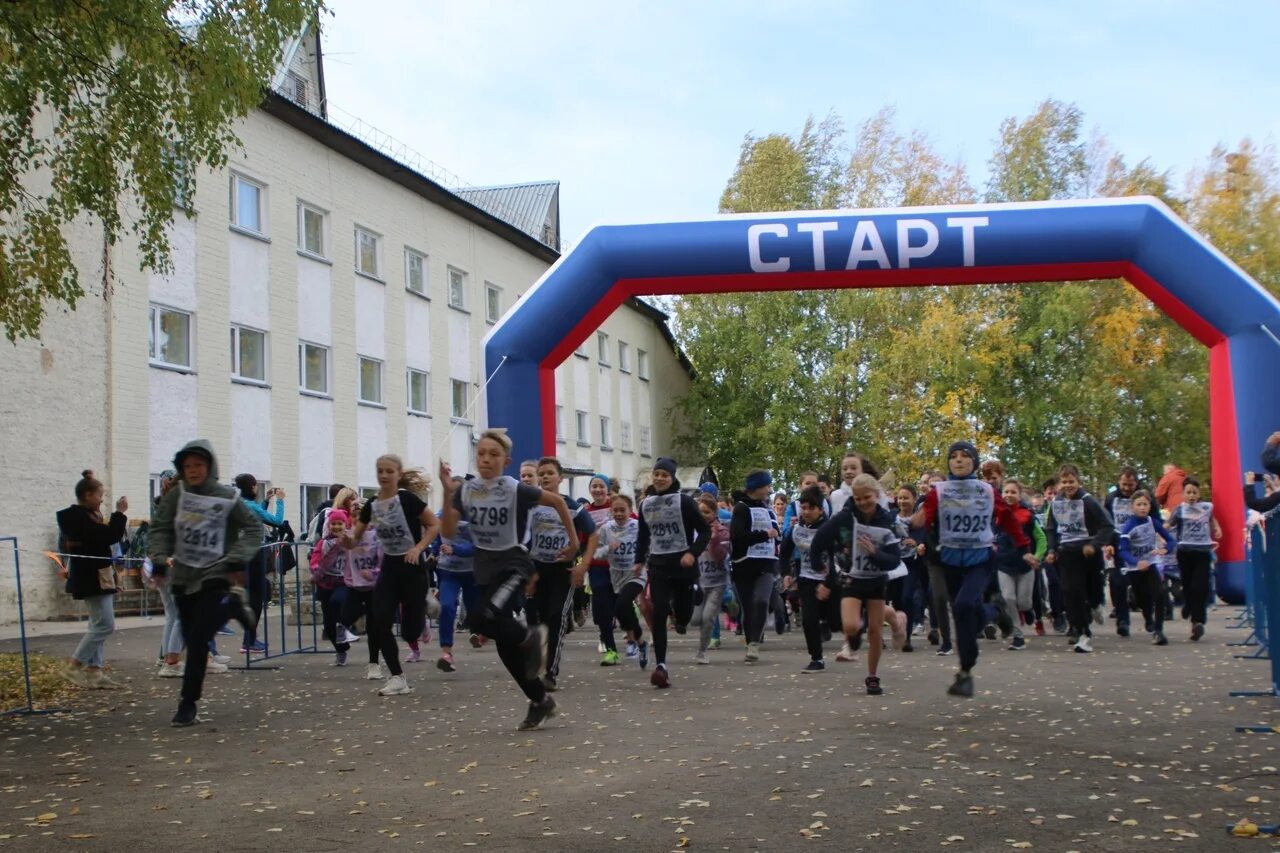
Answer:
0 608 1280 853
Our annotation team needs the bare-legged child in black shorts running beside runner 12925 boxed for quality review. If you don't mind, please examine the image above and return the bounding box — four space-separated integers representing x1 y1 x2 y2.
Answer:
806 474 902 695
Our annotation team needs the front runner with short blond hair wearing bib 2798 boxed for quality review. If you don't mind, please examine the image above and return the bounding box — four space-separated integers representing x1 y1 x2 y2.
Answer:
440 429 579 730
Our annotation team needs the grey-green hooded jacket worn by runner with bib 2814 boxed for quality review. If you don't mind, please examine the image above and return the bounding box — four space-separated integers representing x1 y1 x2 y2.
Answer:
147 438 262 592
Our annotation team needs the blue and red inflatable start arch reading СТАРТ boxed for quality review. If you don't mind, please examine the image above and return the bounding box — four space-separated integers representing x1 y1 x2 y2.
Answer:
485 197 1280 581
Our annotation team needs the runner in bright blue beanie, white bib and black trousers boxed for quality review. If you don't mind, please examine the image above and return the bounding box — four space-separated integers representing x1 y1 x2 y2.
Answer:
728 469 781 662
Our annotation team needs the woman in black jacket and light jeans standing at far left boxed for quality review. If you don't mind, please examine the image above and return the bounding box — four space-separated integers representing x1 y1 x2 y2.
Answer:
58 471 129 689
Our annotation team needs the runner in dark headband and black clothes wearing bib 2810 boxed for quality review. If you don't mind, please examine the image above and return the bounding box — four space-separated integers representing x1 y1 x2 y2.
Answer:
636 456 716 689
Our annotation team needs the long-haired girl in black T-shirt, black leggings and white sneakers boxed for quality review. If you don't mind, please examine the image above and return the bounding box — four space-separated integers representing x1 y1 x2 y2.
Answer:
343 453 438 695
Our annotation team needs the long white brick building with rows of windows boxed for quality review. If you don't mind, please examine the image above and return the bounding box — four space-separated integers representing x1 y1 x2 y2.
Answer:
0 19 689 622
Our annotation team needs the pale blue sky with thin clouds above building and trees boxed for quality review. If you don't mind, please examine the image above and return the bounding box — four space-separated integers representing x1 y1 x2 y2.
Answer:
324 0 1280 241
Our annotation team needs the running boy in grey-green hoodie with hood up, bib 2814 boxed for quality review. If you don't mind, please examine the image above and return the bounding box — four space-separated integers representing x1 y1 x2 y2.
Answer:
147 438 262 726
